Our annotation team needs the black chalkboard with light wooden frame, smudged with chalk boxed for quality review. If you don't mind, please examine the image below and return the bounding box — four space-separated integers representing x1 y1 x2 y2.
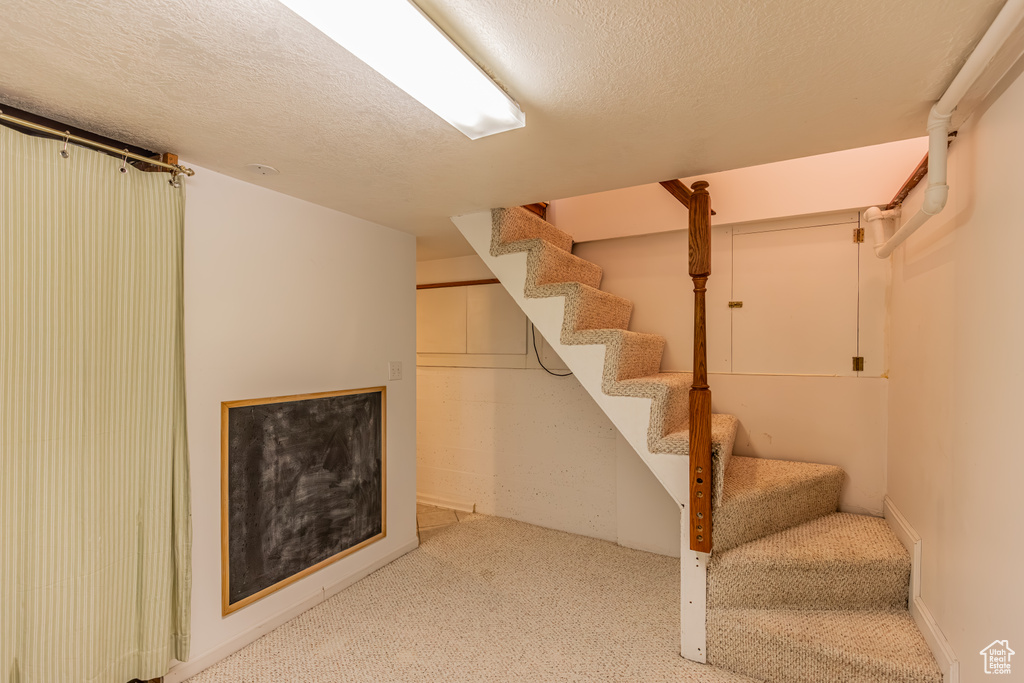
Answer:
221 387 387 615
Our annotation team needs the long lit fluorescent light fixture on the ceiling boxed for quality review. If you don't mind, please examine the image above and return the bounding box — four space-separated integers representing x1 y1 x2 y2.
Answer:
281 0 526 140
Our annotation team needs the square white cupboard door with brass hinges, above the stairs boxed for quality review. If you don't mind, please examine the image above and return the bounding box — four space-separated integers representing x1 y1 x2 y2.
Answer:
731 222 858 377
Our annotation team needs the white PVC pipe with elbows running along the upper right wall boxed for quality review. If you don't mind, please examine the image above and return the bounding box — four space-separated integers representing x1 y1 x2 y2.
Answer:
864 0 1024 258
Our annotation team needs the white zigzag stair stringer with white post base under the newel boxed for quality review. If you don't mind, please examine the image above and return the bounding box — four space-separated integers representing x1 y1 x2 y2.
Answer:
452 210 708 663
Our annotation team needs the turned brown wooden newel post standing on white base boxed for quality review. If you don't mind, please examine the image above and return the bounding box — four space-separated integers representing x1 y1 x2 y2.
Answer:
689 180 712 553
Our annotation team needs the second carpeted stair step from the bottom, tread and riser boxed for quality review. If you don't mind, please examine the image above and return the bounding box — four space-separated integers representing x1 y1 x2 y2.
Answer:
708 512 910 609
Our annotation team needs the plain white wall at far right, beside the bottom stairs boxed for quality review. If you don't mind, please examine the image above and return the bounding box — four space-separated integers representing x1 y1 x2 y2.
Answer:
889 65 1024 683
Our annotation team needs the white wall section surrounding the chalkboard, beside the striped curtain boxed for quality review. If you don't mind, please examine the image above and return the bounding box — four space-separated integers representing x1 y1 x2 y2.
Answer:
167 169 416 683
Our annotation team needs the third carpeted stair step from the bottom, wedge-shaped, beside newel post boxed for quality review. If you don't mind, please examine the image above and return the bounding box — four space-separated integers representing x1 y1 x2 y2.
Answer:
713 456 845 553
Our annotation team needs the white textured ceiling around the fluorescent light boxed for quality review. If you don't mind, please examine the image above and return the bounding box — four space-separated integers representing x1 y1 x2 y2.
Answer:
0 0 1002 257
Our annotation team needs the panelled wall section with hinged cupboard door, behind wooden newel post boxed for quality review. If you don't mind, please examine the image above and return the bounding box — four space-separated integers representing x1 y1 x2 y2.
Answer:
573 211 889 377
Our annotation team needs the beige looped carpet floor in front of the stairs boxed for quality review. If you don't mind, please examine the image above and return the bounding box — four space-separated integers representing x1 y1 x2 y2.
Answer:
189 515 752 683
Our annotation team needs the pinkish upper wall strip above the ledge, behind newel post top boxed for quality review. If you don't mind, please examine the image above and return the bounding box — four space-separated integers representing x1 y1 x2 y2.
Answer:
548 137 928 242
